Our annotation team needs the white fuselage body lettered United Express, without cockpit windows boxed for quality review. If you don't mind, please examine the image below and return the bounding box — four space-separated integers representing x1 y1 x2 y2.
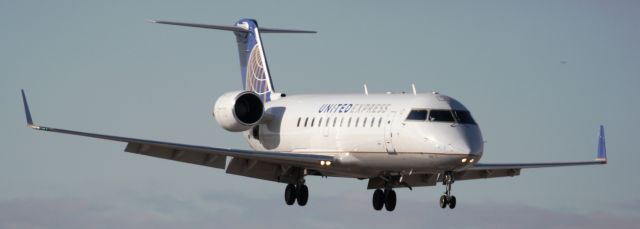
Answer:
243 94 483 177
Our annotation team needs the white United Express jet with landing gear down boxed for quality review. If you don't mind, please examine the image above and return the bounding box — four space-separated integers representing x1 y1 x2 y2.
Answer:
21 19 607 211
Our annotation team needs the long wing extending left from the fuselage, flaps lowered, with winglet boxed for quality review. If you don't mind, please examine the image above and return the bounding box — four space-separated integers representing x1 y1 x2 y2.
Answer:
22 90 334 181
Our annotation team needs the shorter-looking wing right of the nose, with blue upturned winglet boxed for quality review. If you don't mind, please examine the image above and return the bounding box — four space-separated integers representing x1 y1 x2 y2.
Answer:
454 126 607 180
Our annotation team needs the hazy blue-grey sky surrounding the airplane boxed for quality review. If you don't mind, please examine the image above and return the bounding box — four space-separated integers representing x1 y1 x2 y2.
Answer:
0 0 640 228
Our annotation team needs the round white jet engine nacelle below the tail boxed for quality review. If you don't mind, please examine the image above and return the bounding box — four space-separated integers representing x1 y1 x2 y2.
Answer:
213 91 264 132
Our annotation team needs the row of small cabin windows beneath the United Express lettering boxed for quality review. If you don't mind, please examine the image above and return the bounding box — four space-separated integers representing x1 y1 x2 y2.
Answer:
296 117 382 127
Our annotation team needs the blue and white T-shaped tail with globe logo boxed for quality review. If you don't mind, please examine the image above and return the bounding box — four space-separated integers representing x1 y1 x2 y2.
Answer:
151 19 316 102
